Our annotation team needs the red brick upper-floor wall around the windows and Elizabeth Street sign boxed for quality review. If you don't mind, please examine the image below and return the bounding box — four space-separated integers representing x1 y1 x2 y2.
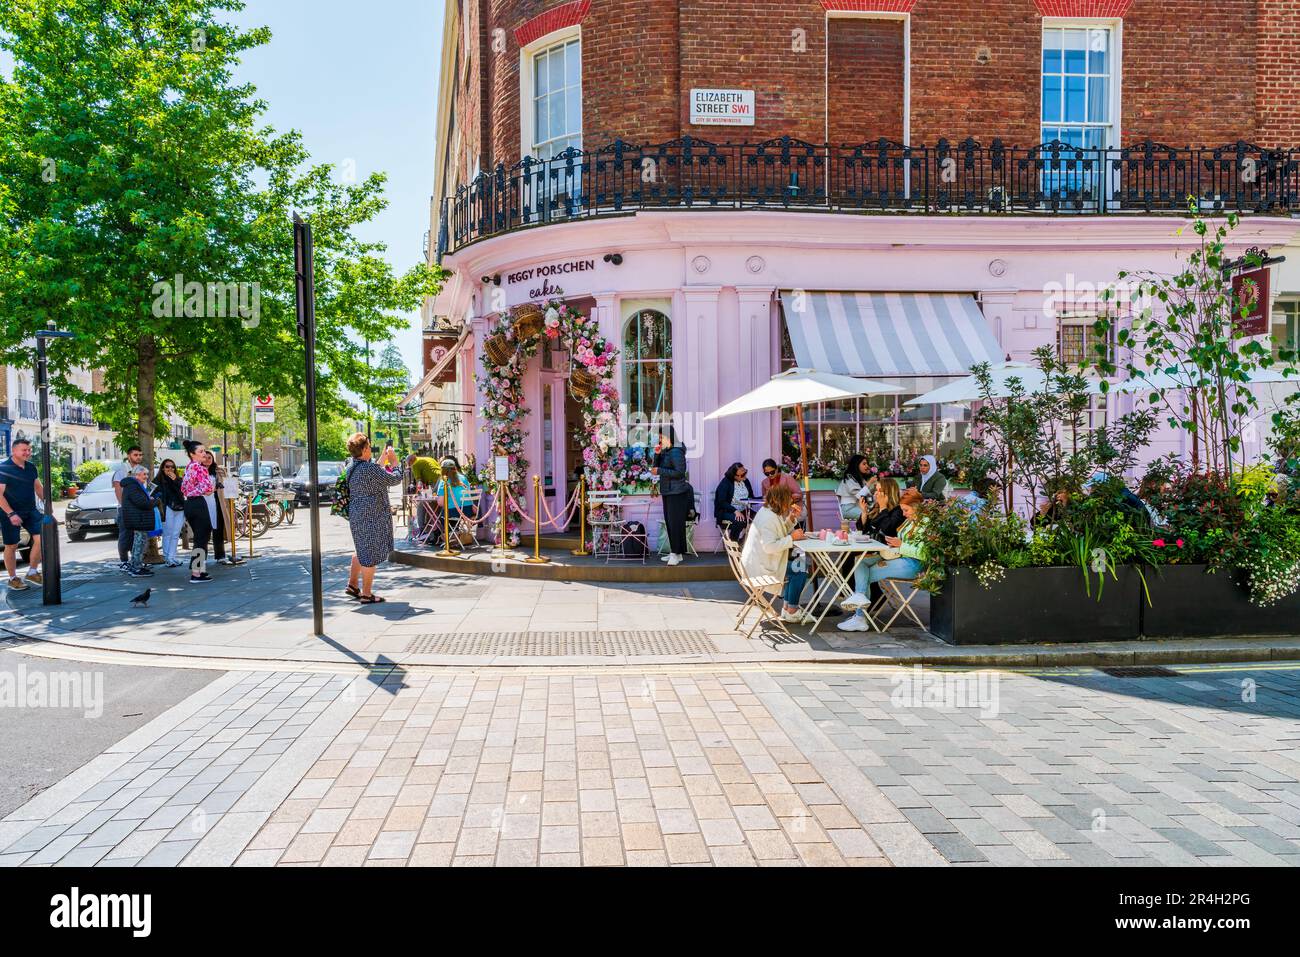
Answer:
449 0 1300 178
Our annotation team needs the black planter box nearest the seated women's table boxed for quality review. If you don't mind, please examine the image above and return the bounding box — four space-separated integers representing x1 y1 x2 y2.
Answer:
930 566 1151 645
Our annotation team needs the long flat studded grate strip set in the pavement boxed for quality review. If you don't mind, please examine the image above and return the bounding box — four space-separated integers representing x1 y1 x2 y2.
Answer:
406 631 718 657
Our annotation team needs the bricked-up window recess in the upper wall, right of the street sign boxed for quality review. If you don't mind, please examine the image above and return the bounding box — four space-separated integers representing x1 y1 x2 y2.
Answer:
827 18 905 144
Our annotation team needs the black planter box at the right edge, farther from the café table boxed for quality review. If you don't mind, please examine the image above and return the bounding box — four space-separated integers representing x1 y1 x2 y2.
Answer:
1141 564 1300 638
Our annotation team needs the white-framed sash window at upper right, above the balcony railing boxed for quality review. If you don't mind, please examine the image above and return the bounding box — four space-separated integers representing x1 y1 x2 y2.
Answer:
1041 23 1118 148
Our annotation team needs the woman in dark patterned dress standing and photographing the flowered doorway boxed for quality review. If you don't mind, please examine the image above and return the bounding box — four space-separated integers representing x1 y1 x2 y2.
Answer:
347 432 402 605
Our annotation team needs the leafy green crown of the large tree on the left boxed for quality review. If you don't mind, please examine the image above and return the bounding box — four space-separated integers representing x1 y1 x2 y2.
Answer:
0 0 439 454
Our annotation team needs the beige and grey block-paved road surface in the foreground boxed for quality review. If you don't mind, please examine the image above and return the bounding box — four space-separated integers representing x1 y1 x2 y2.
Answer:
0 666 1300 866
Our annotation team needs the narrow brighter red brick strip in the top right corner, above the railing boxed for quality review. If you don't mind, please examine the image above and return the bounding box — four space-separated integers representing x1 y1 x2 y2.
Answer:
1255 0 1300 147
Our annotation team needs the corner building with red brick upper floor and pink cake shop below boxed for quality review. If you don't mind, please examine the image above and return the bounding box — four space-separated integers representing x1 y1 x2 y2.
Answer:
425 0 1300 541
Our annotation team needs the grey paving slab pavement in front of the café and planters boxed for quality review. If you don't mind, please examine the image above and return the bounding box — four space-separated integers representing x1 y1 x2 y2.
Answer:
0 516 1300 667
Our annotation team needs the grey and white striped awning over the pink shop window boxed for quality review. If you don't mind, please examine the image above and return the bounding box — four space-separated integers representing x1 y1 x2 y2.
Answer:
781 290 1002 377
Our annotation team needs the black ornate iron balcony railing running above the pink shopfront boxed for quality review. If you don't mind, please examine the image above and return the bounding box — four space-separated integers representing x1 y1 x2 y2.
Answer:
437 137 1300 260
